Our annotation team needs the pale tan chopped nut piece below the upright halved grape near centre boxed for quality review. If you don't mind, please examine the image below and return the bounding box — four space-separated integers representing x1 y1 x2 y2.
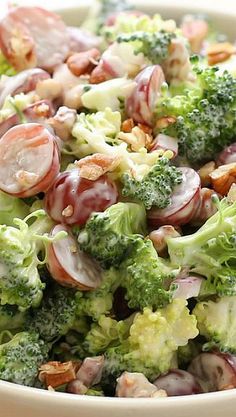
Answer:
118 126 152 152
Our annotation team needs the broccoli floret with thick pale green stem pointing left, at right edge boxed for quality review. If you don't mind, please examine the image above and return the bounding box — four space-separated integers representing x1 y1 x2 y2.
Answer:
167 199 236 296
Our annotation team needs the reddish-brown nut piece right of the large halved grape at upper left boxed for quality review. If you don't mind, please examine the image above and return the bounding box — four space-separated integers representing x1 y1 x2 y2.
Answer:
66 48 100 77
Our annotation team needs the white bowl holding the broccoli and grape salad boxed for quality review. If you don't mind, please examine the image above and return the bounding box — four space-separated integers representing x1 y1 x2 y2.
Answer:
0 0 236 417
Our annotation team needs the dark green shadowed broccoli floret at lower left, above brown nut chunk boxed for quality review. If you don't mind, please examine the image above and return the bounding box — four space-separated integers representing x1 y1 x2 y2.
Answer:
29 285 76 341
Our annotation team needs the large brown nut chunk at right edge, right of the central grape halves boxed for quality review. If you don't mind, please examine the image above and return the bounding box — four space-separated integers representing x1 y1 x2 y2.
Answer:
209 162 236 196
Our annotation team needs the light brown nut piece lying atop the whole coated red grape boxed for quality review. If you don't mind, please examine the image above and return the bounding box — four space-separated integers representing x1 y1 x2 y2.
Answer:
75 153 121 181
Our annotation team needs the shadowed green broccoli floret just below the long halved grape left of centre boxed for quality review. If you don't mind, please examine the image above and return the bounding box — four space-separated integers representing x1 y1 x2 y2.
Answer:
76 268 121 321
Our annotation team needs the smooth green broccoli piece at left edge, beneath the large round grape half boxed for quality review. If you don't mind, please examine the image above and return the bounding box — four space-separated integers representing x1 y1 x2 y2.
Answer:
0 191 30 226
